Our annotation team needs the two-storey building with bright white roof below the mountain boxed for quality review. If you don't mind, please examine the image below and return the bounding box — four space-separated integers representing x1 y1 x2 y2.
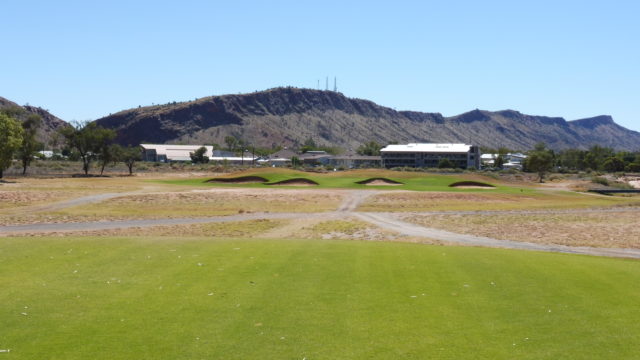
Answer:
380 144 480 169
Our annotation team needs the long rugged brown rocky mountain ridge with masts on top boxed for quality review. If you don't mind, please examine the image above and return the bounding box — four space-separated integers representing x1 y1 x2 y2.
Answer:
96 87 640 150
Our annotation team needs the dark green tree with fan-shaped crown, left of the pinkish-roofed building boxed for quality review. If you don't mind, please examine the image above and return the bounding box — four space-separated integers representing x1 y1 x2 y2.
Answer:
59 122 116 175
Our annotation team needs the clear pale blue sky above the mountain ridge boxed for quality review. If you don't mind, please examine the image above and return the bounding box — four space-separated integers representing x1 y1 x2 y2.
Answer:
0 0 640 131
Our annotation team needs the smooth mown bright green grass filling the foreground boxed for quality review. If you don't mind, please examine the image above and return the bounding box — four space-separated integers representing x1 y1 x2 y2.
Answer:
0 237 640 360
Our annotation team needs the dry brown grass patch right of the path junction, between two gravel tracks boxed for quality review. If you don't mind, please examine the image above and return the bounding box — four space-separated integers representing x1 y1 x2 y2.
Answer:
406 211 640 248
